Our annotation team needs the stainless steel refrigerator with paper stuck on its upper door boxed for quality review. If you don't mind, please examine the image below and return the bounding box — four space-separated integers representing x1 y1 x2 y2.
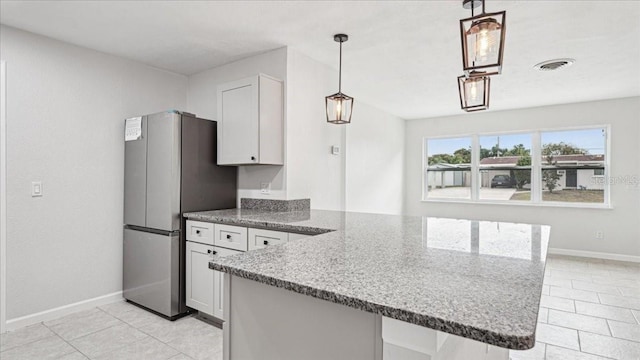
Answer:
123 111 237 319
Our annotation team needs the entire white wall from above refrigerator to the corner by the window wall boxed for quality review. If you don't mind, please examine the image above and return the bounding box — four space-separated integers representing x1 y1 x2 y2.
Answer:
187 48 404 213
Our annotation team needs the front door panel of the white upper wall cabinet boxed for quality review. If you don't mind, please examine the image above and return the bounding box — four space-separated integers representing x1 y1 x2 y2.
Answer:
218 77 260 165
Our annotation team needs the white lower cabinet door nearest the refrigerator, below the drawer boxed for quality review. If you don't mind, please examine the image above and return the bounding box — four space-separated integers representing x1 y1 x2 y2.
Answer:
185 241 215 315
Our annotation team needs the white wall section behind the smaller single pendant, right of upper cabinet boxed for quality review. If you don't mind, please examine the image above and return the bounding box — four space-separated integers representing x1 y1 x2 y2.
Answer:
286 48 344 210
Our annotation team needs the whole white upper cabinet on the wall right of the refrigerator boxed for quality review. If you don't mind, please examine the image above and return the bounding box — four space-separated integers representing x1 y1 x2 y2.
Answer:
218 74 284 165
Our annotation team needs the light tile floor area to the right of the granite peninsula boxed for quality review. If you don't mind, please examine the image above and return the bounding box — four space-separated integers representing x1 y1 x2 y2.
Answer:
510 255 640 360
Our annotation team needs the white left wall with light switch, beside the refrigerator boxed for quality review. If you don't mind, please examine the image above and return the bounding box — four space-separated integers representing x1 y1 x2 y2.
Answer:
0 26 187 321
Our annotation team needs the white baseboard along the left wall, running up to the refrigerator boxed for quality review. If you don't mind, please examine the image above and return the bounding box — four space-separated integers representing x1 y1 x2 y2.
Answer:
7 291 124 331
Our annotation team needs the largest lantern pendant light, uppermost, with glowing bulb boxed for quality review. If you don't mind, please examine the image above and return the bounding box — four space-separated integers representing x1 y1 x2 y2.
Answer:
460 0 506 77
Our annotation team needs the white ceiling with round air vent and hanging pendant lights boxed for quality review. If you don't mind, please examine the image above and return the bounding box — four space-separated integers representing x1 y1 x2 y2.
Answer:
0 0 640 119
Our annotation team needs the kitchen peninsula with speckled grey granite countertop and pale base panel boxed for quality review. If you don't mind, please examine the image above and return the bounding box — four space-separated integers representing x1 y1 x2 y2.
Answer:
184 209 550 359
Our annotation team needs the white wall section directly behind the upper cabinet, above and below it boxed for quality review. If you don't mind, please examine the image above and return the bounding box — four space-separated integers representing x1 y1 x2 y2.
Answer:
187 47 287 205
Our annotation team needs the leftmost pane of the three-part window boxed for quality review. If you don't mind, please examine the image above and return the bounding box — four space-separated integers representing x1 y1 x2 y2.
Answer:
425 137 471 199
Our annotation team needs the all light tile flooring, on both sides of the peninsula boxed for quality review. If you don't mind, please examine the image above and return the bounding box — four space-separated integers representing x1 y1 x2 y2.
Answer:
0 256 640 360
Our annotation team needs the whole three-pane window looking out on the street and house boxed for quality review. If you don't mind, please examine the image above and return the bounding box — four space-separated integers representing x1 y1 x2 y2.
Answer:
423 127 608 204
